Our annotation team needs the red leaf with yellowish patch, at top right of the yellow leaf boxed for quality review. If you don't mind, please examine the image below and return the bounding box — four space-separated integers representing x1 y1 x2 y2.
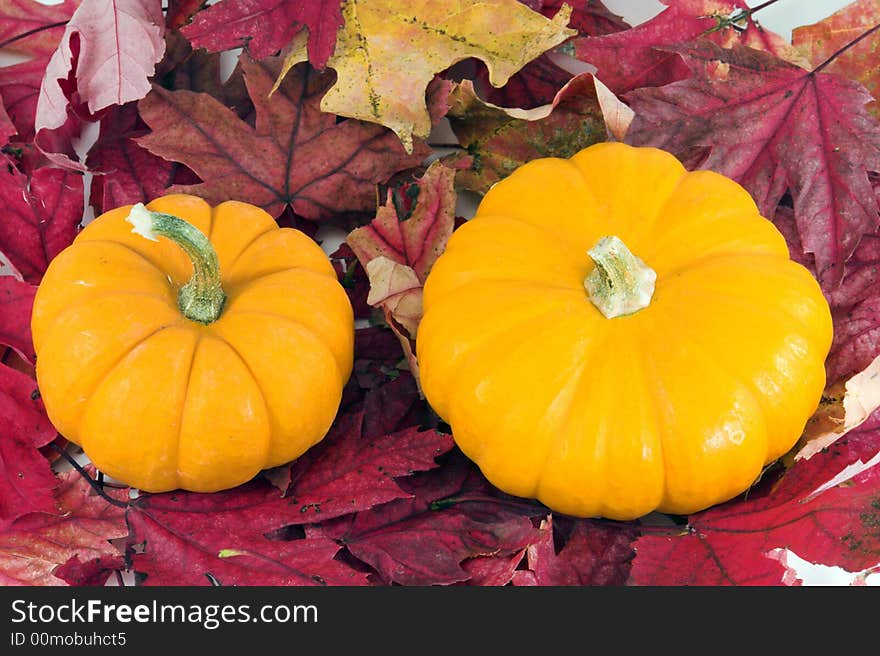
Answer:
572 0 807 94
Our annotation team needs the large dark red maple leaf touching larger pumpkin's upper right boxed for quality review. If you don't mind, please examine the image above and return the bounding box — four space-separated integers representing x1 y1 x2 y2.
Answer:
626 40 880 290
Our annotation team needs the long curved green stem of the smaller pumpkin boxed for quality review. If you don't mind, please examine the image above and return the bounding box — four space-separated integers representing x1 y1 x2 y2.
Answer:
125 203 226 324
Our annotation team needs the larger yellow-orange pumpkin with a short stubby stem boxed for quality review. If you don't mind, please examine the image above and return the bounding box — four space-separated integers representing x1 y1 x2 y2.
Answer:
416 143 832 520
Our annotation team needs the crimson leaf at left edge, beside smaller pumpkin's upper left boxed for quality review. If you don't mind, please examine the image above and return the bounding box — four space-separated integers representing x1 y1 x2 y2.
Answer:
0 167 83 283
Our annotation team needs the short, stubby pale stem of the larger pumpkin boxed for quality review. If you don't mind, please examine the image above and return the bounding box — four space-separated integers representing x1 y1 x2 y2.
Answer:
584 235 657 319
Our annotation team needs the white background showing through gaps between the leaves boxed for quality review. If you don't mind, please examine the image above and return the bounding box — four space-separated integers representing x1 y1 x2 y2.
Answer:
0 0 880 585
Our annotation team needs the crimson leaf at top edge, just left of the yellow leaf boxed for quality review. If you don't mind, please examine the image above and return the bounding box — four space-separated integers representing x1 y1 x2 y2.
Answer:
181 0 342 69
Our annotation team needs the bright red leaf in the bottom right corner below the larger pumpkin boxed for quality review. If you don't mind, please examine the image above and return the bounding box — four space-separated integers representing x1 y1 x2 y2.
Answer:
630 420 880 585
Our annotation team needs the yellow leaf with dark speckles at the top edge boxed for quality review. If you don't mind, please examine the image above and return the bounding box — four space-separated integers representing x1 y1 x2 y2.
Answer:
321 0 576 150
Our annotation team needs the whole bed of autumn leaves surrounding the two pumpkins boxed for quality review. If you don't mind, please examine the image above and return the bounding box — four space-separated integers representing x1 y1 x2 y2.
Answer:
0 0 880 585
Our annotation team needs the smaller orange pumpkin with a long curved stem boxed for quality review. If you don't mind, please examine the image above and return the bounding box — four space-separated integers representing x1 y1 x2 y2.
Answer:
32 194 354 492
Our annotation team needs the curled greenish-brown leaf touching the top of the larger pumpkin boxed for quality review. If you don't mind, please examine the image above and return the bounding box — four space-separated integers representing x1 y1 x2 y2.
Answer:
446 73 608 194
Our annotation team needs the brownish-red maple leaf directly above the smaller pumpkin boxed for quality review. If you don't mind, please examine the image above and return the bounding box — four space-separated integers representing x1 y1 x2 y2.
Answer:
138 56 428 221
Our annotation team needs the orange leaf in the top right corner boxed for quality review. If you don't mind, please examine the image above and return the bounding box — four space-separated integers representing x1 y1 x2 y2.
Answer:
791 0 880 117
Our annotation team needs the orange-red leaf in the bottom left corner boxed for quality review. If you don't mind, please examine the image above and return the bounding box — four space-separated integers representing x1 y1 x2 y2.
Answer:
0 471 128 586
